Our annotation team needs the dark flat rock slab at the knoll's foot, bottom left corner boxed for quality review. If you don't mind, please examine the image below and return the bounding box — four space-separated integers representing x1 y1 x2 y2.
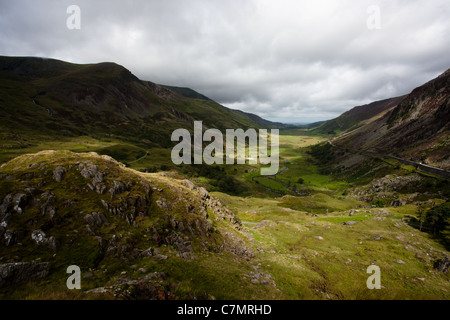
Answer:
0 262 50 288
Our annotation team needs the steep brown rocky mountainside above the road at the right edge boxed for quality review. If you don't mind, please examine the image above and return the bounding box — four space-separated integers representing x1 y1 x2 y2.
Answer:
334 69 450 168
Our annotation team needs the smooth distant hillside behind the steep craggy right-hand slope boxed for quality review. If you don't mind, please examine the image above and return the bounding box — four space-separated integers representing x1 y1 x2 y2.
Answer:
311 96 405 134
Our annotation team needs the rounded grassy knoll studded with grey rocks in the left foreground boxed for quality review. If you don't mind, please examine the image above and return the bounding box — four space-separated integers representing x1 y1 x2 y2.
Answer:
0 151 279 299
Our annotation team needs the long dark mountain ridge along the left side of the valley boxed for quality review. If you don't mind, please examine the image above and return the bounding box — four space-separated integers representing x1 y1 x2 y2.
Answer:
0 56 280 147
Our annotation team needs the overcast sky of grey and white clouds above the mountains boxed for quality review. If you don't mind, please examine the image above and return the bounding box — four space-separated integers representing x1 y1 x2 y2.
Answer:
0 0 450 122
